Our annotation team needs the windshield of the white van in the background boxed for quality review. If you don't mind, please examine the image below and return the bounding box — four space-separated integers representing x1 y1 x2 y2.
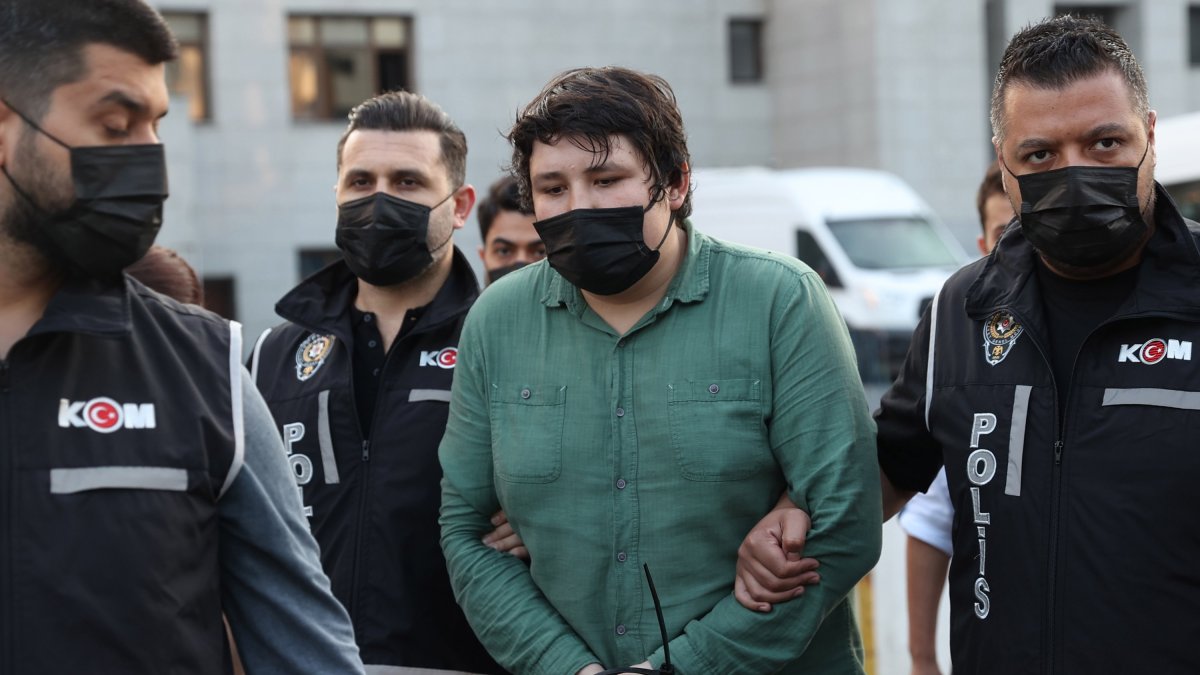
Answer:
829 217 959 269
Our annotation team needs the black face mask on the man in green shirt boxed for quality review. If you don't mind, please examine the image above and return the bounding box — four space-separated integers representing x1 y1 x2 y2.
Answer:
533 203 674 295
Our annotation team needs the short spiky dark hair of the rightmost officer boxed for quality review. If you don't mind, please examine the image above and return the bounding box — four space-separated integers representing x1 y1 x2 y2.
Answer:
991 14 1150 139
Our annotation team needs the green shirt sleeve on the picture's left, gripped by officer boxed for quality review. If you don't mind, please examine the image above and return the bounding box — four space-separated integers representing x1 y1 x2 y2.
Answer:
439 314 600 675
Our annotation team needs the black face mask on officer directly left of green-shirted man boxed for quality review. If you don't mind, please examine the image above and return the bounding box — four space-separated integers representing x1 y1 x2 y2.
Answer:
335 192 454 286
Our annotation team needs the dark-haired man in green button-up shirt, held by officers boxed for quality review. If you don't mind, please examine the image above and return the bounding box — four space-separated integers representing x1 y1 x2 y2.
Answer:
440 67 881 675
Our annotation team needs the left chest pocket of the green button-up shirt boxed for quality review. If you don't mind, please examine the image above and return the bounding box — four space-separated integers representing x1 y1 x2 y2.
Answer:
491 384 566 483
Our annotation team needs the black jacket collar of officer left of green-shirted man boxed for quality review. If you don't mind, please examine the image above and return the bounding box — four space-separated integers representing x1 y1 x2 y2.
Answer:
275 246 479 339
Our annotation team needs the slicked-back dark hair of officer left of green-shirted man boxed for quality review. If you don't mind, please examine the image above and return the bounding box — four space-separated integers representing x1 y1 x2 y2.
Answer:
337 91 467 190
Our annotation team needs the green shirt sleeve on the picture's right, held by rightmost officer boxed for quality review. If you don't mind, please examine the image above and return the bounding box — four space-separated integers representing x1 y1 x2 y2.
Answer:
650 273 882 675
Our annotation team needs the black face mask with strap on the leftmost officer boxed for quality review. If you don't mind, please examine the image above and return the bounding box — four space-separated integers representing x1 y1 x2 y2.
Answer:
0 101 167 281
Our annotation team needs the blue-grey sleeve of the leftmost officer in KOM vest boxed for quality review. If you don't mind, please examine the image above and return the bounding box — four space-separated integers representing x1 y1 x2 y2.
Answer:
217 370 362 675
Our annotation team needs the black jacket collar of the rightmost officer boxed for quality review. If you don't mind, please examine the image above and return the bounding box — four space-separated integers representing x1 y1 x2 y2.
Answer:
966 183 1200 321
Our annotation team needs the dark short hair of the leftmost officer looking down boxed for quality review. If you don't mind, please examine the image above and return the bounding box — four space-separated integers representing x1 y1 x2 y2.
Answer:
0 0 179 121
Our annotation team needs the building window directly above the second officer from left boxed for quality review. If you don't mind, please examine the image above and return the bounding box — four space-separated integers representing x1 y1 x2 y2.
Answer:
288 16 412 120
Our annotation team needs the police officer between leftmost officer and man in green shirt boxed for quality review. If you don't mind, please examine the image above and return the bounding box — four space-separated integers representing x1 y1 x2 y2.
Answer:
252 91 499 673
